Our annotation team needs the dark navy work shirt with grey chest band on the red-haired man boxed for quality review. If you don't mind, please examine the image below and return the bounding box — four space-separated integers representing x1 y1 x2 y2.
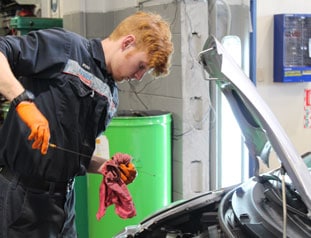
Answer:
0 28 118 181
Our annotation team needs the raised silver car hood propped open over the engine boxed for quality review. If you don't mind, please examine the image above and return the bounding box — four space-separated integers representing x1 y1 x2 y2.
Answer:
199 36 311 214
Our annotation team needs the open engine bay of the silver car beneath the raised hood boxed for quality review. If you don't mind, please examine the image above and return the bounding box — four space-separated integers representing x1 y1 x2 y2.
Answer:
127 174 311 238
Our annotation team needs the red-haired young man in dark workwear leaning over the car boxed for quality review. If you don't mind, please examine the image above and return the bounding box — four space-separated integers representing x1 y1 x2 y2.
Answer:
0 12 173 238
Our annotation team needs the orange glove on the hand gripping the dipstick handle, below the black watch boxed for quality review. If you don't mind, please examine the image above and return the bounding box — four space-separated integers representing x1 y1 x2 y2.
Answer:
16 101 51 155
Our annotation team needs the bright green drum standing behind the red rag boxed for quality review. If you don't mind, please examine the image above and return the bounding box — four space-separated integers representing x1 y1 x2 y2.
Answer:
87 111 172 238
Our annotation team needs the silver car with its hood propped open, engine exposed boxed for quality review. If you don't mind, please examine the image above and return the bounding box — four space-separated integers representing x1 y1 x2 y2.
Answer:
115 36 311 238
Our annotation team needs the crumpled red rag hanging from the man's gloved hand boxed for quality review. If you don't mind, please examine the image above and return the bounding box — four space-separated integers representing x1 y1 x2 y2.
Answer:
96 156 136 220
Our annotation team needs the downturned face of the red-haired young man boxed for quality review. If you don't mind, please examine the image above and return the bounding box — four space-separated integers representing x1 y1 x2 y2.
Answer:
111 40 149 82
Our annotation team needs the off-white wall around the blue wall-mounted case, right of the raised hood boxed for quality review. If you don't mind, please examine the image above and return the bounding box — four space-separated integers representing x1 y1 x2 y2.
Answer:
257 0 311 171
